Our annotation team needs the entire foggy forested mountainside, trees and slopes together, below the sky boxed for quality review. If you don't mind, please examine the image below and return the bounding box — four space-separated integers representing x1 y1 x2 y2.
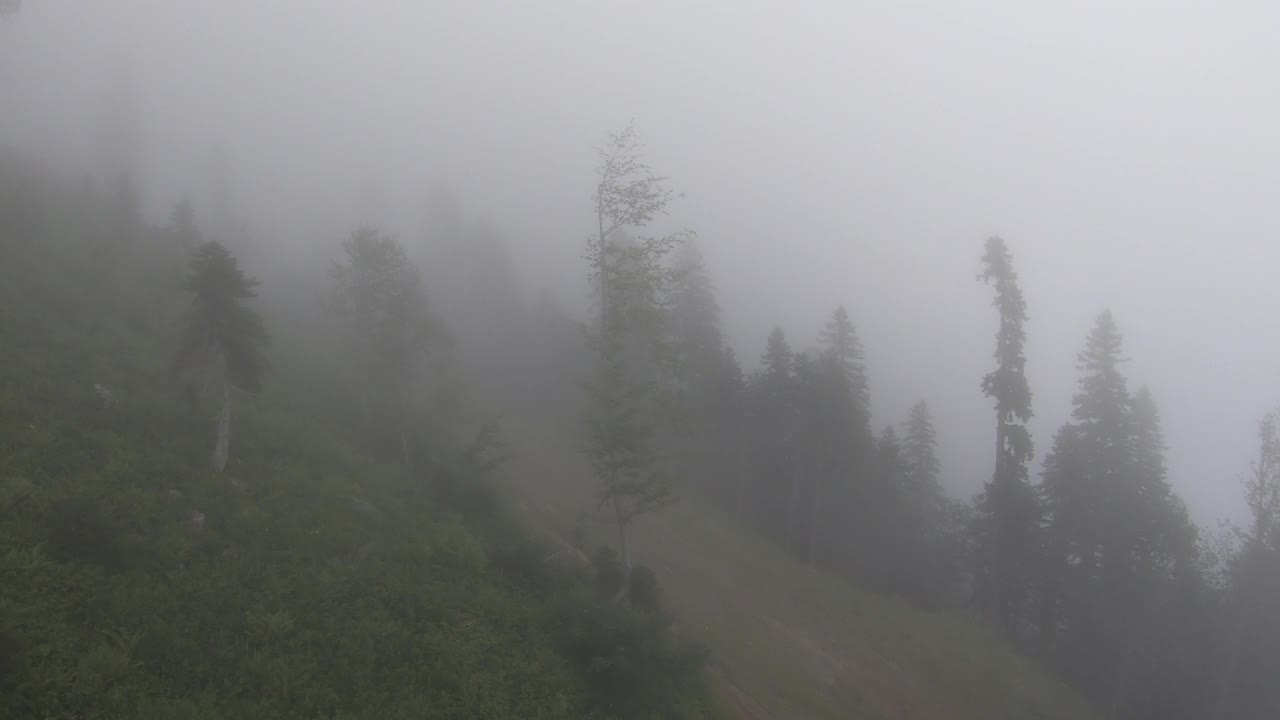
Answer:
0 3 1280 720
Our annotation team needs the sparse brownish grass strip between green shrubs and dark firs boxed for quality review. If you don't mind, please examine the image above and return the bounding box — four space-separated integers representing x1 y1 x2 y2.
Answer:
494 420 1094 720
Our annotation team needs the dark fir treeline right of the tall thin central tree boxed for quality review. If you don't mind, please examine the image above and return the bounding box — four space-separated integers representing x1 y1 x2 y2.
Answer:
650 233 1280 719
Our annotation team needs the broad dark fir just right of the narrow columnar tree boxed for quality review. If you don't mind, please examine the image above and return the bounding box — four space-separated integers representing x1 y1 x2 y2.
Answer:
1039 311 1199 719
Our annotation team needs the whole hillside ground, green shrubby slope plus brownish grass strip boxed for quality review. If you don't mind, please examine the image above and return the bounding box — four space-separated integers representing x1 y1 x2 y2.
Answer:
0 167 1091 720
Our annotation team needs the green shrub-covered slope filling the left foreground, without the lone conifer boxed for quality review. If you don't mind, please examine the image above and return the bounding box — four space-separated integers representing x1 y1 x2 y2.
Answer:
0 219 709 720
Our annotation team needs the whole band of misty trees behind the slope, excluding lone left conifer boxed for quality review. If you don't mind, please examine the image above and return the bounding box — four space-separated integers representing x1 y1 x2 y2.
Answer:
10 113 1280 720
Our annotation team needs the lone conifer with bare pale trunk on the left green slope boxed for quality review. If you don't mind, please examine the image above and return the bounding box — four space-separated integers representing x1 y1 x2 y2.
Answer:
174 242 269 473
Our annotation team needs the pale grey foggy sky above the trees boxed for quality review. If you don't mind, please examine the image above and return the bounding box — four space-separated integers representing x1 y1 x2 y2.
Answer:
0 0 1280 523
